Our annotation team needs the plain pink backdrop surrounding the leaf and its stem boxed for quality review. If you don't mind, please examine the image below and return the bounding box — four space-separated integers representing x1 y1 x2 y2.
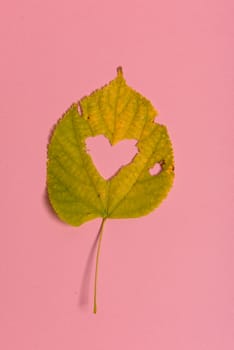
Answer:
0 0 234 350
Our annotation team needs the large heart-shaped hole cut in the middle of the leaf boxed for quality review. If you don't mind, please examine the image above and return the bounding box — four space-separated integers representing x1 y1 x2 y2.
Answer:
85 135 138 180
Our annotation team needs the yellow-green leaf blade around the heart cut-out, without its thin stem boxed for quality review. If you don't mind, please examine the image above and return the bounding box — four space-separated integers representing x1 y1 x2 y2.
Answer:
47 68 174 226
